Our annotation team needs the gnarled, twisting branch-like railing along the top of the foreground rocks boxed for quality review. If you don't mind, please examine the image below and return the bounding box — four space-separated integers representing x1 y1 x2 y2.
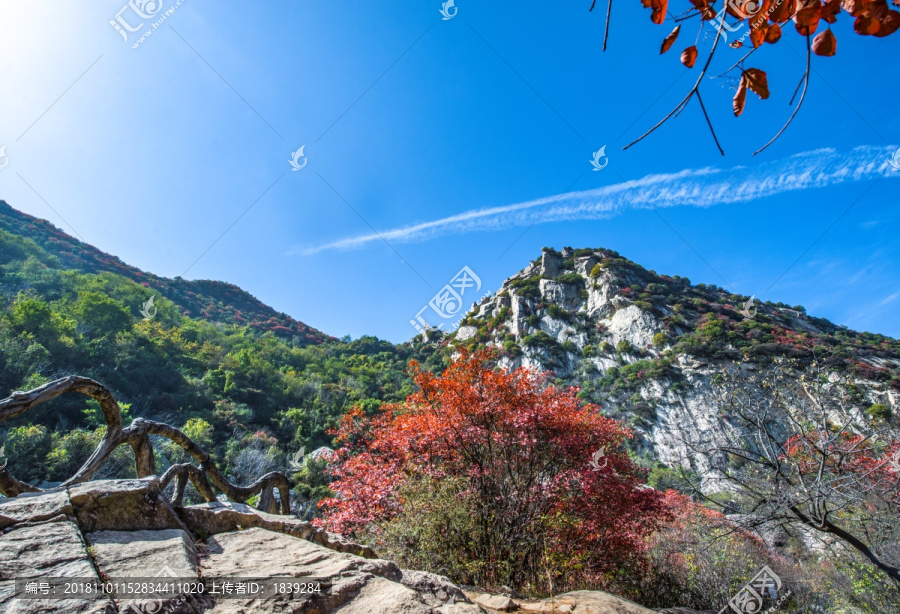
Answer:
0 375 290 514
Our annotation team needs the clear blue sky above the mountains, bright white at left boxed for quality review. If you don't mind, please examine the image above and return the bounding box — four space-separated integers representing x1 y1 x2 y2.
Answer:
0 0 900 341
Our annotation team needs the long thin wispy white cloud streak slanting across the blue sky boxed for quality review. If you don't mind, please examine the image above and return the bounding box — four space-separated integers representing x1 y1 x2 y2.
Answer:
289 146 900 255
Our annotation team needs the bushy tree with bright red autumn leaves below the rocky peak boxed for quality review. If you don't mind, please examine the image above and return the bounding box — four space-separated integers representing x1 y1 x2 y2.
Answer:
320 351 666 586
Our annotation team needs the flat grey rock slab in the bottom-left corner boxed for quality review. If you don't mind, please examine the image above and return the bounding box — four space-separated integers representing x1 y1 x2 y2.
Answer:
0 516 118 614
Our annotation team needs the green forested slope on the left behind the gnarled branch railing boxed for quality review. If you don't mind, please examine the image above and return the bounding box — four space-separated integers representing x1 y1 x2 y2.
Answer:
0 209 438 498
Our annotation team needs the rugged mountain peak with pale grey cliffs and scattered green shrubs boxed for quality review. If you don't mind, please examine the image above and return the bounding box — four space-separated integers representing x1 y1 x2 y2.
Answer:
449 248 900 478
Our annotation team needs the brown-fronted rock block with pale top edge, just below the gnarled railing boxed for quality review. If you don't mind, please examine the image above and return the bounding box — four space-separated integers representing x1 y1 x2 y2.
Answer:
69 477 186 533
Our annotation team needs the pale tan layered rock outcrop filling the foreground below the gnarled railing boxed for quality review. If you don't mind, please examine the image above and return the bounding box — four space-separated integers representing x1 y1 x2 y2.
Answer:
0 477 651 614
